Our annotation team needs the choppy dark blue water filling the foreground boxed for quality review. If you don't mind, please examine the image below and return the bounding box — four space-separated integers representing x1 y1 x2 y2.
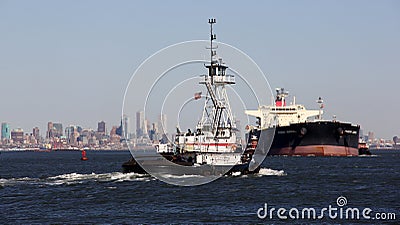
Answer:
0 151 400 224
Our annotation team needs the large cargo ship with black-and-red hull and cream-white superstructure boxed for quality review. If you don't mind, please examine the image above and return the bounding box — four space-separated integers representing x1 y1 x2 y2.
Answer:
246 88 360 156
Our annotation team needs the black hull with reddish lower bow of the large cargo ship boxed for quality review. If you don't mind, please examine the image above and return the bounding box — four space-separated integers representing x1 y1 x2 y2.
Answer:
255 121 360 156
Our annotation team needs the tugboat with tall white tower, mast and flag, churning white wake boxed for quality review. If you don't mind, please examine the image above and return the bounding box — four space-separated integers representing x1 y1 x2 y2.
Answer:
123 19 260 174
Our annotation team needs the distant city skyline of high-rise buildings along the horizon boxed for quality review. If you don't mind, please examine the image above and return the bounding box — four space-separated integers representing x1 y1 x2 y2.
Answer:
0 116 398 150
